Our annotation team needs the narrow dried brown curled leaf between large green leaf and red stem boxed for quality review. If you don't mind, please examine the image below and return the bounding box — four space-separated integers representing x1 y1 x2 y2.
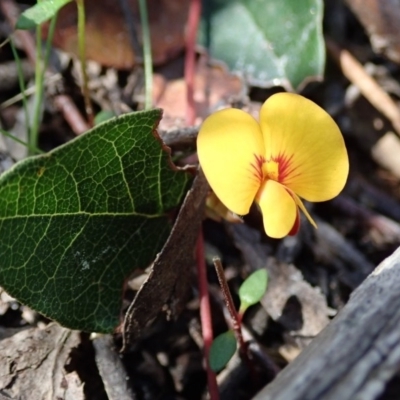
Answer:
123 171 209 350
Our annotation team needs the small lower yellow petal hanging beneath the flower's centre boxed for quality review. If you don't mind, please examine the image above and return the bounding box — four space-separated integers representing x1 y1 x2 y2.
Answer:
256 179 297 239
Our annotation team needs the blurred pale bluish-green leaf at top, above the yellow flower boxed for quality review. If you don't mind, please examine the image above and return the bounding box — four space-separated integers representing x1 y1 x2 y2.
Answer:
199 0 325 90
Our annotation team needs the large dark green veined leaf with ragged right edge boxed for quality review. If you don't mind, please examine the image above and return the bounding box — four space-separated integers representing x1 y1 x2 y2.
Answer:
0 110 188 332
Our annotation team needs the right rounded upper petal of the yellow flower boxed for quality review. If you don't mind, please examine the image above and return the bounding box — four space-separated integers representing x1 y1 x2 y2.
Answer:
260 93 349 201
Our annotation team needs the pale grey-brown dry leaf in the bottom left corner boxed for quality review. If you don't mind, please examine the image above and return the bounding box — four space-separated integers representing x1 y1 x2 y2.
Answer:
0 324 85 400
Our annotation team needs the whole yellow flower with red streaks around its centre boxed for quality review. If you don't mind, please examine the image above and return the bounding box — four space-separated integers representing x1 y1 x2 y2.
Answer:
197 93 349 238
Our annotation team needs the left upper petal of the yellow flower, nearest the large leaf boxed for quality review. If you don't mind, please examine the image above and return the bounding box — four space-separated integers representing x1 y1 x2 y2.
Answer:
197 108 264 215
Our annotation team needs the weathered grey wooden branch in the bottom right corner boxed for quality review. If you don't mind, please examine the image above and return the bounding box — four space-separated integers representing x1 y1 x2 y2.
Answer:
253 249 400 400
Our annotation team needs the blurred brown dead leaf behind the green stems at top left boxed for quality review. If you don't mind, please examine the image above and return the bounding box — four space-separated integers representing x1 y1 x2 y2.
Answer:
44 0 189 69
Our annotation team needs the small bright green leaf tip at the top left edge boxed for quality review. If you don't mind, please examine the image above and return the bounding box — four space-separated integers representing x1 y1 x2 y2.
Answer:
15 0 71 29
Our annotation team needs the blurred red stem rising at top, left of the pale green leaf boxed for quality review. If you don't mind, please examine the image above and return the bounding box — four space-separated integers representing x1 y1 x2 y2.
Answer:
185 0 201 126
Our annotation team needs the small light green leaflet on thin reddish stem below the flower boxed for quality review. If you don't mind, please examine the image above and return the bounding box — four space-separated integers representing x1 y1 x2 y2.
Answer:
239 269 268 313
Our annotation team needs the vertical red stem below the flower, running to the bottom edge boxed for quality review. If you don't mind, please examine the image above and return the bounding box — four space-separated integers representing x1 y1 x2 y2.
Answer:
196 230 219 400
